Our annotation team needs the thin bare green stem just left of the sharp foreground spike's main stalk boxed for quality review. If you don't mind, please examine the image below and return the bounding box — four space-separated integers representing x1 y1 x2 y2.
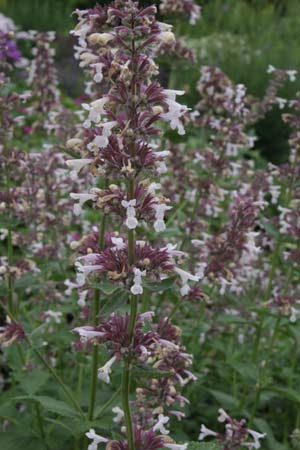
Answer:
88 214 105 420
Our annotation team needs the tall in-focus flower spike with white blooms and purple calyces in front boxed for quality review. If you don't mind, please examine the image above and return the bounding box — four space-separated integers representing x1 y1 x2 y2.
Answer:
67 1 198 450
